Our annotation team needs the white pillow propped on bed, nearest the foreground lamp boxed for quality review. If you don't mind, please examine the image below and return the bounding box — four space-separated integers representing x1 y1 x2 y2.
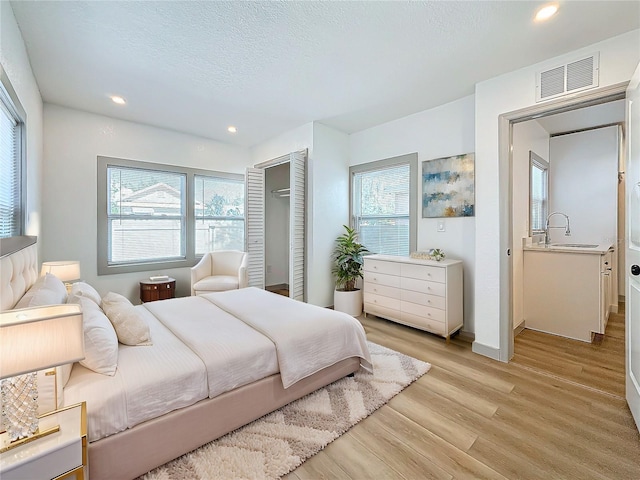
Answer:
72 297 118 376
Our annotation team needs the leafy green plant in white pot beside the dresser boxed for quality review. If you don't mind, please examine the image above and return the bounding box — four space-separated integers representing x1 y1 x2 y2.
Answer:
332 225 369 317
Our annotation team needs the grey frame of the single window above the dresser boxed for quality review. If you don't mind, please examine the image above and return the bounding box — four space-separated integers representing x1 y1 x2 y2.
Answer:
349 152 418 255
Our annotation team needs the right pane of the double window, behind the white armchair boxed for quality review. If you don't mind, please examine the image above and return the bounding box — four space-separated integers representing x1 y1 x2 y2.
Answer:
194 175 244 255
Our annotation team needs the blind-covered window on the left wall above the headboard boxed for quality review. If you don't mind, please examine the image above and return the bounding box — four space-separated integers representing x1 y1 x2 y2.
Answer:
0 68 26 238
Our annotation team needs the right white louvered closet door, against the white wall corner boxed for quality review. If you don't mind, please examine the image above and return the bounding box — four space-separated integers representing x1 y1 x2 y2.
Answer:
289 151 306 302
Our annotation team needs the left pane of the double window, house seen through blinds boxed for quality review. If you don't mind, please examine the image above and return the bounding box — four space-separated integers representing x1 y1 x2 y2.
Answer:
107 165 187 265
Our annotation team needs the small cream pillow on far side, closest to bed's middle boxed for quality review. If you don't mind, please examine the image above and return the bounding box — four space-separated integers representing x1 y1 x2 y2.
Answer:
102 292 151 345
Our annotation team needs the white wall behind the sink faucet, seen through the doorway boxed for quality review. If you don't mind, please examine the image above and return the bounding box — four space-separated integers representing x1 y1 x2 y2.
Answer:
549 126 618 245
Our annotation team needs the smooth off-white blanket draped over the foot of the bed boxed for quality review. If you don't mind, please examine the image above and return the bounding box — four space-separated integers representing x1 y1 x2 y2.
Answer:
202 287 372 388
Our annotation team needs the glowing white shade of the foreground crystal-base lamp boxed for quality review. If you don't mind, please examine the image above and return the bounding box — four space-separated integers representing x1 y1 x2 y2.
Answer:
0 304 84 379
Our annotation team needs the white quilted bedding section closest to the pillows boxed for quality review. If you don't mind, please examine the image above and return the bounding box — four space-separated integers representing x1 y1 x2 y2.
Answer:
64 305 207 442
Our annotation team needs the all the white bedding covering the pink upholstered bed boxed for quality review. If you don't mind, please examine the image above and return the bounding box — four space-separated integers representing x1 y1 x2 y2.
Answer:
64 288 371 441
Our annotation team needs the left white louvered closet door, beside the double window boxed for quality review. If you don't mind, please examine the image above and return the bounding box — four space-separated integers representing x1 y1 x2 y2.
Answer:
245 168 265 289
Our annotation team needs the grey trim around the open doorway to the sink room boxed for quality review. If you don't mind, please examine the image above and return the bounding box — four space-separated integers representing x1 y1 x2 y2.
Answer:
498 81 629 362
